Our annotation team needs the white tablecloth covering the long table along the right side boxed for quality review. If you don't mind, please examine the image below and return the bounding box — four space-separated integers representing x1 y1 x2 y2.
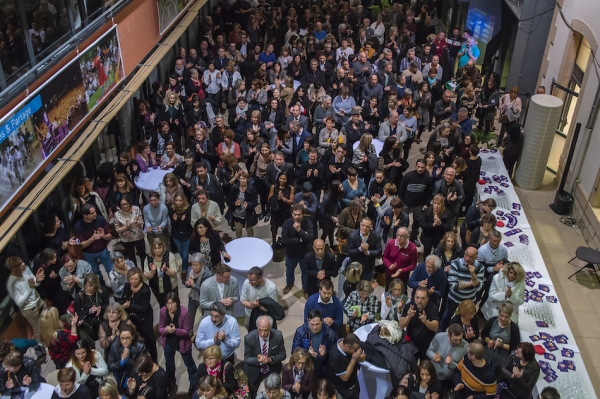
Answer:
477 150 597 399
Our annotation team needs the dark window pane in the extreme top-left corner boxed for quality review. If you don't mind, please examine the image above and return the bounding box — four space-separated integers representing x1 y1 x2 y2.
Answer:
0 0 31 84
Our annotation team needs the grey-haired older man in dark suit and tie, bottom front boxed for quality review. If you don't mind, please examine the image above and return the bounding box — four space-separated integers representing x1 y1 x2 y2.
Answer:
244 316 286 399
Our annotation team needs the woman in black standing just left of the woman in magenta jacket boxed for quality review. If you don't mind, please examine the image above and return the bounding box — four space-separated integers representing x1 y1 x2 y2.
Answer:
120 267 158 363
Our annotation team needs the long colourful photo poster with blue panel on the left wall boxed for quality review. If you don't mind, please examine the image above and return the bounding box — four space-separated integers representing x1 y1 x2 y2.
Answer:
0 26 125 216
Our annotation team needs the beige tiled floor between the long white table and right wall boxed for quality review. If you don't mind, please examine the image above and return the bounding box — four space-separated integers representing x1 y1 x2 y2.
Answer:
516 172 600 392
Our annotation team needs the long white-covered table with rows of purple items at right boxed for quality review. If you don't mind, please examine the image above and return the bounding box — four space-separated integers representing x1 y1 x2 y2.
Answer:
477 150 597 399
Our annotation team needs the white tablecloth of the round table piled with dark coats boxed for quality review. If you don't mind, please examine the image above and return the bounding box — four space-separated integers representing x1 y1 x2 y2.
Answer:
354 323 392 399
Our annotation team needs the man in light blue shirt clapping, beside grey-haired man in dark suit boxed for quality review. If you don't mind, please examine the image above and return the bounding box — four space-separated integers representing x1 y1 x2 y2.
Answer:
195 302 241 364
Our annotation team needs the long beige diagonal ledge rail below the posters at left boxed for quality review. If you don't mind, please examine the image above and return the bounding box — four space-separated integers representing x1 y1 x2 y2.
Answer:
0 0 207 251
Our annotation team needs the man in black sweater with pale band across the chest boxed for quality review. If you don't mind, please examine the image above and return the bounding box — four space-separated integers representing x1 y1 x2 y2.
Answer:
398 158 431 247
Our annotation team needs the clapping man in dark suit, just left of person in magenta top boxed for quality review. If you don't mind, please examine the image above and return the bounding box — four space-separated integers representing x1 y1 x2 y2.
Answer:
348 218 382 281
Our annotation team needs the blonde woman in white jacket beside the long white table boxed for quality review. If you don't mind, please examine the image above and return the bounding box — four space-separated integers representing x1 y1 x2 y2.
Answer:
481 262 525 323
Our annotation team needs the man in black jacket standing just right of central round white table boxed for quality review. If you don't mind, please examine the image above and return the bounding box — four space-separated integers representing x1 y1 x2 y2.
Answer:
281 204 313 296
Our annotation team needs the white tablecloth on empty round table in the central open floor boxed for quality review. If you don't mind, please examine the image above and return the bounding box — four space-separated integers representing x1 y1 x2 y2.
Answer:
225 237 273 317
